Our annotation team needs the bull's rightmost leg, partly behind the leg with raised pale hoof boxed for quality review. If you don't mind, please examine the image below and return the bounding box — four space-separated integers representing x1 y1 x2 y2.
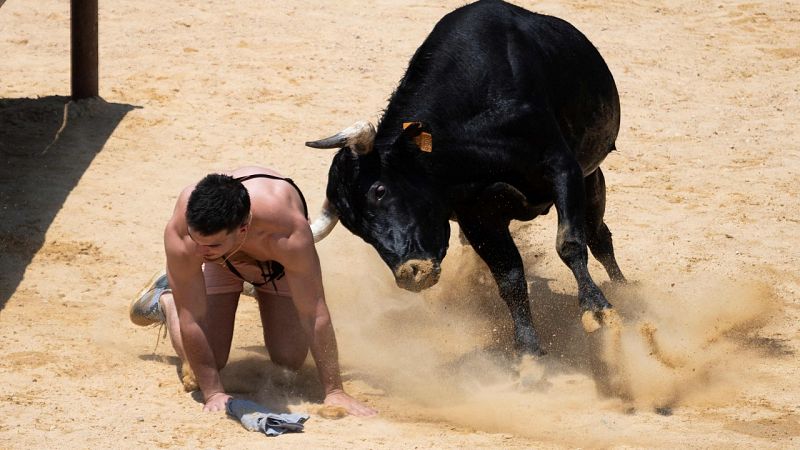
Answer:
583 167 625 283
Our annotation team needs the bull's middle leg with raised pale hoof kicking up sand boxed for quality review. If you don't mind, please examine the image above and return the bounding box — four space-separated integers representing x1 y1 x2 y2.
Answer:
550 156 611 332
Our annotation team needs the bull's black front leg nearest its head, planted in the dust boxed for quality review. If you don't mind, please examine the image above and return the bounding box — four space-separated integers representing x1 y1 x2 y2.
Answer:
458 214 545 356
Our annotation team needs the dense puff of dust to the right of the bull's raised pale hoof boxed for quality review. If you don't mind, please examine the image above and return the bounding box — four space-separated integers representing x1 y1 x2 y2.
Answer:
600 275 778 407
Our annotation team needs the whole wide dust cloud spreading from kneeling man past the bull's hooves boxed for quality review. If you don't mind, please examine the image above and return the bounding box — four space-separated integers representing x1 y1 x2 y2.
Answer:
321 232 774 445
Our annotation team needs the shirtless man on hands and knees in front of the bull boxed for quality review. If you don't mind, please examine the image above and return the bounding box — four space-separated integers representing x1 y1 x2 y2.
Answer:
130 167 376 416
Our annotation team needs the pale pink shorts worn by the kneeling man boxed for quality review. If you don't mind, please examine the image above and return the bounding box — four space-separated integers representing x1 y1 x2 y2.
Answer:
203 261 292 297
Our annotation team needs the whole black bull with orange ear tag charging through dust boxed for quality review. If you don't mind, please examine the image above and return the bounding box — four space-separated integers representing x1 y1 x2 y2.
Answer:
307 0 625 354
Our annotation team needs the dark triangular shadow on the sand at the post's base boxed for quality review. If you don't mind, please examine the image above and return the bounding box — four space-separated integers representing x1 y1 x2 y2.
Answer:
0 96 137 312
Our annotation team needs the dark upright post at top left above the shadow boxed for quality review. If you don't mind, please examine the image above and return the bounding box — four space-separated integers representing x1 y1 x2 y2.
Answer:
70 0 99 100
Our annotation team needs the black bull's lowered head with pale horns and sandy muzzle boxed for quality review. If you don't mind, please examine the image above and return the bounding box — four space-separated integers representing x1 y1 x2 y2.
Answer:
306 122 450 292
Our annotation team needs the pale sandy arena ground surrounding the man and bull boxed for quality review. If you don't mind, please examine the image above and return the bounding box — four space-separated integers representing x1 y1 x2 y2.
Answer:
0 0 800 449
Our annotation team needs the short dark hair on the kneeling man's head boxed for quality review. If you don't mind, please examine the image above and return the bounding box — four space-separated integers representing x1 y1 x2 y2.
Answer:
186 173 250 236
